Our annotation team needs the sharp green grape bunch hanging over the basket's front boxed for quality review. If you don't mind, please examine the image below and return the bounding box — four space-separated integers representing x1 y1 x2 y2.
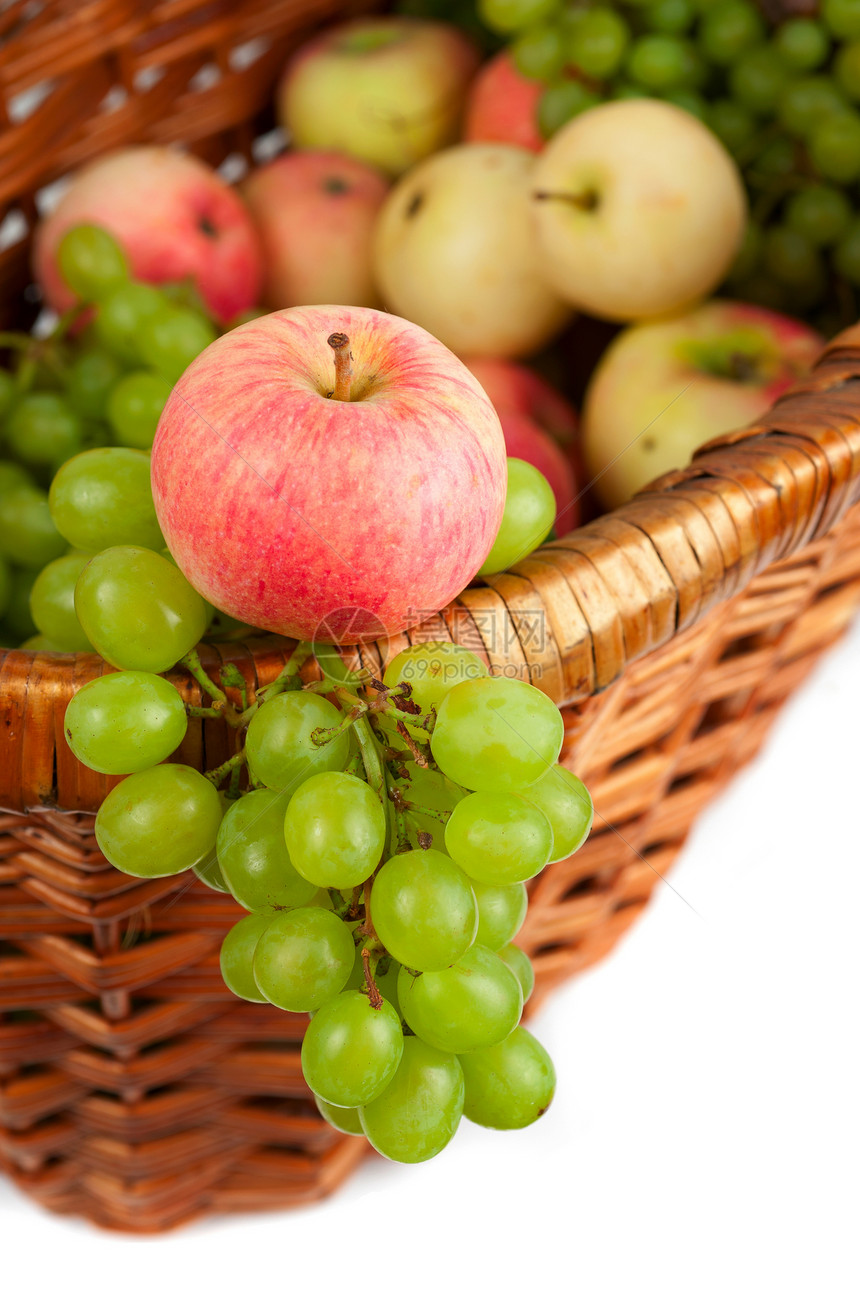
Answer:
65 630 593 1162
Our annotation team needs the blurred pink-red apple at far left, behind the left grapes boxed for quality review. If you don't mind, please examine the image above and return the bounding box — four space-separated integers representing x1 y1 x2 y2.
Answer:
32 147 262 323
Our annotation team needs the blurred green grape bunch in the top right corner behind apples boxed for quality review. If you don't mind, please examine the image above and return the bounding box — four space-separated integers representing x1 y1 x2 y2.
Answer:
479 0 860 333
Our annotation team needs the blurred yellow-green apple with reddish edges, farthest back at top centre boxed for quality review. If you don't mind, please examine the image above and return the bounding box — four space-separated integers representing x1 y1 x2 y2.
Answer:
278 17 478 174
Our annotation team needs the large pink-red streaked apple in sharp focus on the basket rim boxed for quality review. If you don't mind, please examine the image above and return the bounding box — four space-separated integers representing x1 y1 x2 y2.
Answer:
152 306 506 642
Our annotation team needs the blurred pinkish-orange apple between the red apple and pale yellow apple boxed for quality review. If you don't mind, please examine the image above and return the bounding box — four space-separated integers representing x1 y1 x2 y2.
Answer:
243 149 389 310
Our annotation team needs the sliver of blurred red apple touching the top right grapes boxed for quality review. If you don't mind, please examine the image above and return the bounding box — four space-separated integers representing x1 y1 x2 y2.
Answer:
462 49 544 152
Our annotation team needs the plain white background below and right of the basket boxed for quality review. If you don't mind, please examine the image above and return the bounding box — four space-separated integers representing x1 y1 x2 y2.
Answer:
0 612 860 1292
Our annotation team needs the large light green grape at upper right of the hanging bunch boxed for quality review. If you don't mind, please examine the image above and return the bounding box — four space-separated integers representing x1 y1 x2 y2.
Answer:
430 677 564 789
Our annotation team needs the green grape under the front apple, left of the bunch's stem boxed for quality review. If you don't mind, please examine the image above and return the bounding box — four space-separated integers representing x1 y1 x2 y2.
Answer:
245 691 350 791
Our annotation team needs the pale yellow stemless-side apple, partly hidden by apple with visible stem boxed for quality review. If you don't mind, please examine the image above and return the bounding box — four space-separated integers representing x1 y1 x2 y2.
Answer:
373 143 571 358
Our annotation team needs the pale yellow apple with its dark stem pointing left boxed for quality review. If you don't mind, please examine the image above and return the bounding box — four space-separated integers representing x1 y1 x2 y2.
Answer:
532 98 746 320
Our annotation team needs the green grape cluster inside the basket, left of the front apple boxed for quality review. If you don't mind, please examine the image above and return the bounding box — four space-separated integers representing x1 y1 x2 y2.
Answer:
0 225 235 651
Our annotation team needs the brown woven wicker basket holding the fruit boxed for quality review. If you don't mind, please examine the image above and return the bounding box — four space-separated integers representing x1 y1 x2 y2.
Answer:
0 0 860 1231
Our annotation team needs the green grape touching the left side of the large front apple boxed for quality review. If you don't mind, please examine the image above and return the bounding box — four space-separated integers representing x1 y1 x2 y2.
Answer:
49 447 164 552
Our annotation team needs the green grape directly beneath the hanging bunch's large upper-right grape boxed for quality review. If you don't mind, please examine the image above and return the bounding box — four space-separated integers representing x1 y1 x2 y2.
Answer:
445 789 553 885
